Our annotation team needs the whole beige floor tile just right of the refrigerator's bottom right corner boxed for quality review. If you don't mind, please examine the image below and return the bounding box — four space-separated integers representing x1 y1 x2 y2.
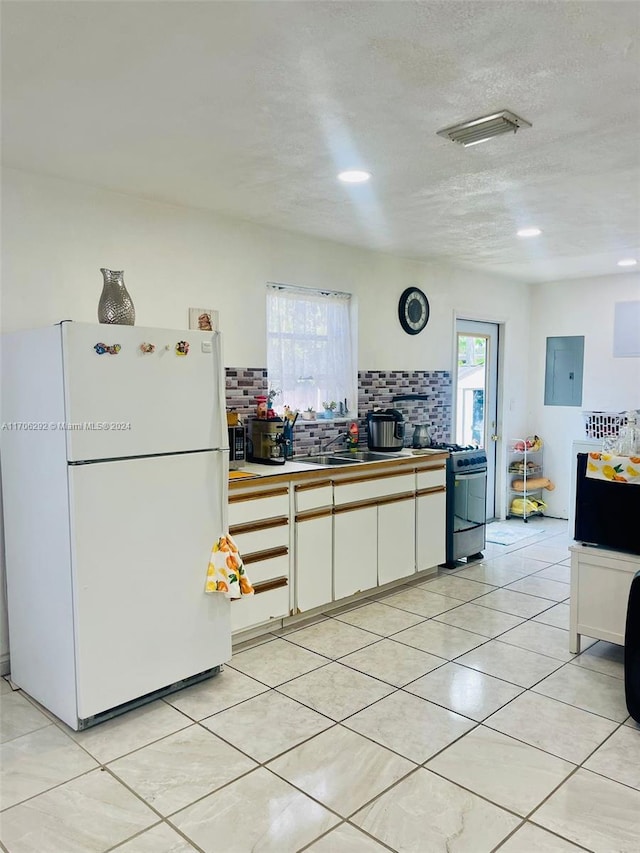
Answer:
229 639 327 687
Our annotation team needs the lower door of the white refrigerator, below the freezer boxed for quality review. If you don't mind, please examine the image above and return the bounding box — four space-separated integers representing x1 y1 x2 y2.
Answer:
69 451 231 719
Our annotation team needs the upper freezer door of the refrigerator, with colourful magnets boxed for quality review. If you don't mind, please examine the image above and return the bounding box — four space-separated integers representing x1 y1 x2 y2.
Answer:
61 322 228 461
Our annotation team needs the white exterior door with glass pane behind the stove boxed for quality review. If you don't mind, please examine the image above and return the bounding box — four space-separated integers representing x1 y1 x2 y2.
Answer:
455 320 500 521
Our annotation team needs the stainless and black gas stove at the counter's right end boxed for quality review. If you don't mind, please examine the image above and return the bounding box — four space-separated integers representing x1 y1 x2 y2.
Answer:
431 443 487 569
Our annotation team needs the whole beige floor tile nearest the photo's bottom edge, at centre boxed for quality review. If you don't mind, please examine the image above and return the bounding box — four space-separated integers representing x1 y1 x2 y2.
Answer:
268 726 415 817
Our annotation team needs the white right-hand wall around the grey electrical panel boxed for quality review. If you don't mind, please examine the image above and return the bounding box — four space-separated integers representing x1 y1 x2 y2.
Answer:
528 273 640 518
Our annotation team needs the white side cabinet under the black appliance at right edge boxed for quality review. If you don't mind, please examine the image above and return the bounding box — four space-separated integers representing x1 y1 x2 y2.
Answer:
569 544 640 654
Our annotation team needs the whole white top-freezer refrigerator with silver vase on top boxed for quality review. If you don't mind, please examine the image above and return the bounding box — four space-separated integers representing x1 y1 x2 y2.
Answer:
1 322 231 729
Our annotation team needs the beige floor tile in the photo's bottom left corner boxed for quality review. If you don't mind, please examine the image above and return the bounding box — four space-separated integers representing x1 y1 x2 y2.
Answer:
2 770 158 853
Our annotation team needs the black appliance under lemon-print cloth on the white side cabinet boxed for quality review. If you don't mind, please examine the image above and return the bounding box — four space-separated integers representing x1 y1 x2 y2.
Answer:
574 453 640 554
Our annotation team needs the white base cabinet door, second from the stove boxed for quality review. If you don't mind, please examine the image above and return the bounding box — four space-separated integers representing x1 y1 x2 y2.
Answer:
378 495 416 584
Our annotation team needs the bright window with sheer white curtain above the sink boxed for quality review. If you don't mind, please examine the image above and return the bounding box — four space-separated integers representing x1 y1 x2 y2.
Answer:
267 284 358 415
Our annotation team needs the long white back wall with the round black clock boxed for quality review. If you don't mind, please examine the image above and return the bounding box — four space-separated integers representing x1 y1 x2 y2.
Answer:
0 170 529 672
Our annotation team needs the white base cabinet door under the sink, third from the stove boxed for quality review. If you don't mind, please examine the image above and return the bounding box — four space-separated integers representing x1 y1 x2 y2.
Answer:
333 505 378 600
